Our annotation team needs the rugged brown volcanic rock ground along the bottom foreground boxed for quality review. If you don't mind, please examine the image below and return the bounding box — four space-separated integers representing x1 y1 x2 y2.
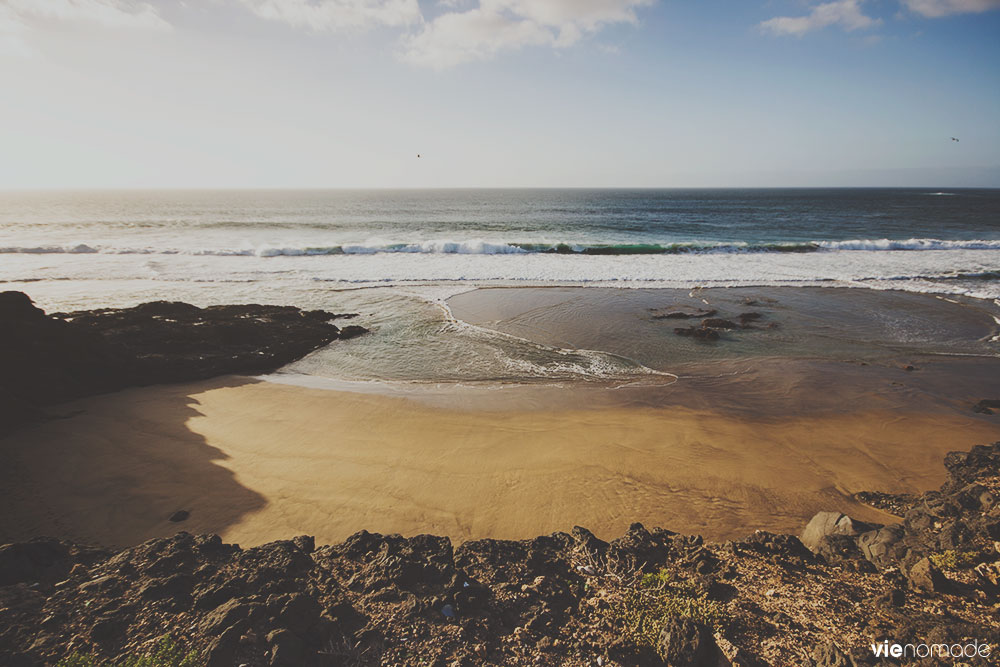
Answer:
0 443 1000 667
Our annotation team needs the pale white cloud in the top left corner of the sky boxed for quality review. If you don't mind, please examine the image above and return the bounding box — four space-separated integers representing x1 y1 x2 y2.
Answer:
0 0 170 57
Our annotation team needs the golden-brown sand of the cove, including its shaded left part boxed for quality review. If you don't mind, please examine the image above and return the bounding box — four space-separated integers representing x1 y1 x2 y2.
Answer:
0 377 1000 546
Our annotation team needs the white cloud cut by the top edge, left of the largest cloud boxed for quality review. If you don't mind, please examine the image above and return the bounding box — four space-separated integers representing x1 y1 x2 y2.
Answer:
240 0 422 32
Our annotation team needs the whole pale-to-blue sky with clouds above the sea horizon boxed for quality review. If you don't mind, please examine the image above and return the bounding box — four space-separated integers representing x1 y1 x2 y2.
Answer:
0 0 1000 189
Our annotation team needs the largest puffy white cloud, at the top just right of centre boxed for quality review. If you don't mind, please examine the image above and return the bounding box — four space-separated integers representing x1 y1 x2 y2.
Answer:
401 0 653 69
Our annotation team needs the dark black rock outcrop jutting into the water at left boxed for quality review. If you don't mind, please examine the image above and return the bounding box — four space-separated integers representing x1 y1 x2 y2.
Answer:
0 292 365 432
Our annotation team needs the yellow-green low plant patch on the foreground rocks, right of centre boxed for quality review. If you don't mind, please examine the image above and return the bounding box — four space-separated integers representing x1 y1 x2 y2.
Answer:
617 569 722 646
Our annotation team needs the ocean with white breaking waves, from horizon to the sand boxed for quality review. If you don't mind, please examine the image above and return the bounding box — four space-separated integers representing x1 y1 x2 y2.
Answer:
0 188 1000 382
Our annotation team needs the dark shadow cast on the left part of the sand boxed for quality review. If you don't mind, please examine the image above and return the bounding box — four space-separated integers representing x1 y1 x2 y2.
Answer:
0 376 267 548
